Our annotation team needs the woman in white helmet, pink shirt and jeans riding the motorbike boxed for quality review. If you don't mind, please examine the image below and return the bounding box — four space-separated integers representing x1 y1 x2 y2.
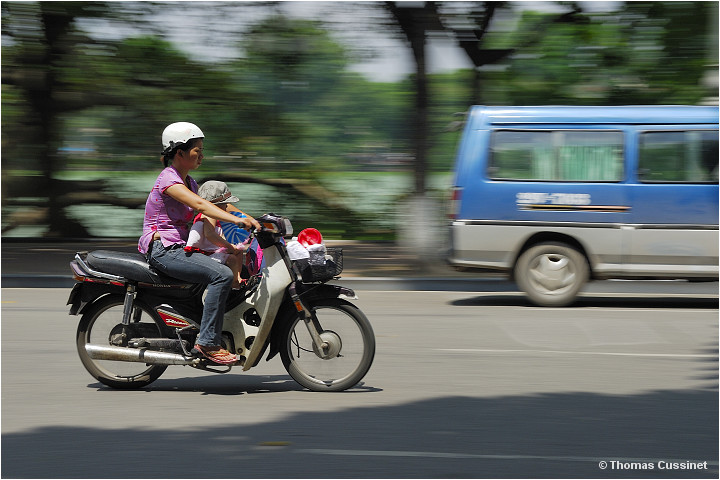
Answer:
138 122 260 365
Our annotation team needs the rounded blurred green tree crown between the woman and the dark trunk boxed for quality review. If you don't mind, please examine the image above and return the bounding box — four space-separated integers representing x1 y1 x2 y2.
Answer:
230 16 416 171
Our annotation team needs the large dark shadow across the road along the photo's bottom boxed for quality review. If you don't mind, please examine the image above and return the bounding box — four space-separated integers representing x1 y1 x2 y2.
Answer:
2 384 718 479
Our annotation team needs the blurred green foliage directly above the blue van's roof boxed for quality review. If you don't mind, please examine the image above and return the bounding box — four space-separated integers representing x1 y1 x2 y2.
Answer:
487 2 717 105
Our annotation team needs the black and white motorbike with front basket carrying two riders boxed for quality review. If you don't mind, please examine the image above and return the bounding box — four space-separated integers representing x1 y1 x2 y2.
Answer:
67 214 375 392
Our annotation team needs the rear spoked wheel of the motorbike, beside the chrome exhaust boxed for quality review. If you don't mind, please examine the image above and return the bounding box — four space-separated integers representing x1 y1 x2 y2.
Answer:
77 295 167 389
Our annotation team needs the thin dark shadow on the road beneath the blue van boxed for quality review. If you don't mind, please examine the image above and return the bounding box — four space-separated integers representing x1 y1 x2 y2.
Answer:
449 295 719 310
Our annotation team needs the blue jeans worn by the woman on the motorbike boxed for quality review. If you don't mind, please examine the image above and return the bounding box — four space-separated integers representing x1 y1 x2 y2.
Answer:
148 240 233 346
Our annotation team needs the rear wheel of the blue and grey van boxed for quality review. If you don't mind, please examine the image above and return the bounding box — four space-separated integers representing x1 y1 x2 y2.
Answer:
514 243 590 307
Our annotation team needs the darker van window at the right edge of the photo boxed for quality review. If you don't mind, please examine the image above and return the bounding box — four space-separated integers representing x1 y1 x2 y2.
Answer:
638 130 718 183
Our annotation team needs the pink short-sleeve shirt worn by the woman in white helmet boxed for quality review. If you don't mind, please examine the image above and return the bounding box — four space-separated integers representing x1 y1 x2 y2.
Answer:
138 167 198 254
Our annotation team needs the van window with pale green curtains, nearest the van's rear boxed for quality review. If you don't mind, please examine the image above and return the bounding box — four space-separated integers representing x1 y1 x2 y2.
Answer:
488 130 624 182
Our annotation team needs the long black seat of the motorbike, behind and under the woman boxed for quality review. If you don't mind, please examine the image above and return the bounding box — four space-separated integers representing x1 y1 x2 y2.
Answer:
85 250 192 286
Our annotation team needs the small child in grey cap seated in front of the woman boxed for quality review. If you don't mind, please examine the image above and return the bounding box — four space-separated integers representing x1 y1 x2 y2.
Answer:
184 180 248 289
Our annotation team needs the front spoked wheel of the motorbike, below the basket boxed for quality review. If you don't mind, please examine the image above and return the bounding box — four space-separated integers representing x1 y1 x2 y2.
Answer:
280 299 375 392
